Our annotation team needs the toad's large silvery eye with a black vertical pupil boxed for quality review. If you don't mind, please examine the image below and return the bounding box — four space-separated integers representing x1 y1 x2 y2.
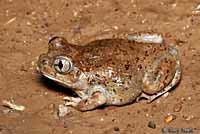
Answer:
54 56 73 73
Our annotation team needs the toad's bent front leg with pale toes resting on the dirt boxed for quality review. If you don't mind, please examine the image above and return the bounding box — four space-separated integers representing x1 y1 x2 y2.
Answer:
64 91 106 111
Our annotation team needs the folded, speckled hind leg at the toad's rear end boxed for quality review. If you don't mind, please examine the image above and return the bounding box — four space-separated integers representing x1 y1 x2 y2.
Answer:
138 48 181 102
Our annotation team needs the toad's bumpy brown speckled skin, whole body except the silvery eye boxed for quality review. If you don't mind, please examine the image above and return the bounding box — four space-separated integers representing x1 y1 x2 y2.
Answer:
38 37 181 111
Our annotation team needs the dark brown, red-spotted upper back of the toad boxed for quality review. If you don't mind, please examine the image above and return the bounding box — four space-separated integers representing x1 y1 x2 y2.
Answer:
74 39 168 73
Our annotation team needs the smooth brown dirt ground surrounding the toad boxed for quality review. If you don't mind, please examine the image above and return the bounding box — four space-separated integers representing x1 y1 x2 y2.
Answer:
0 0 200 134
